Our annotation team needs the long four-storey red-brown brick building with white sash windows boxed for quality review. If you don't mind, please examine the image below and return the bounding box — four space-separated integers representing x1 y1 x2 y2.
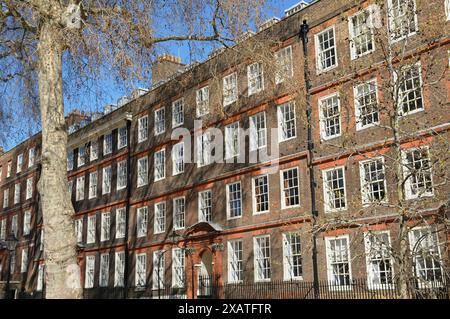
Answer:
0 0 450 297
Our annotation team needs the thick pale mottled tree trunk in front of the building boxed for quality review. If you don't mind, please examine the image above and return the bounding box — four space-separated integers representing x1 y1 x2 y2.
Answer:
38 22 82 298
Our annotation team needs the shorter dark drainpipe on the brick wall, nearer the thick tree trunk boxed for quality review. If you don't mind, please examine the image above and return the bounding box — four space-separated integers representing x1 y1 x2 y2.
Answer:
123 113 132 299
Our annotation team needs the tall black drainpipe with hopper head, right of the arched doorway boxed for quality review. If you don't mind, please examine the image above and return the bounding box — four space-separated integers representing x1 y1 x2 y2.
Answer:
299 20 319 299
